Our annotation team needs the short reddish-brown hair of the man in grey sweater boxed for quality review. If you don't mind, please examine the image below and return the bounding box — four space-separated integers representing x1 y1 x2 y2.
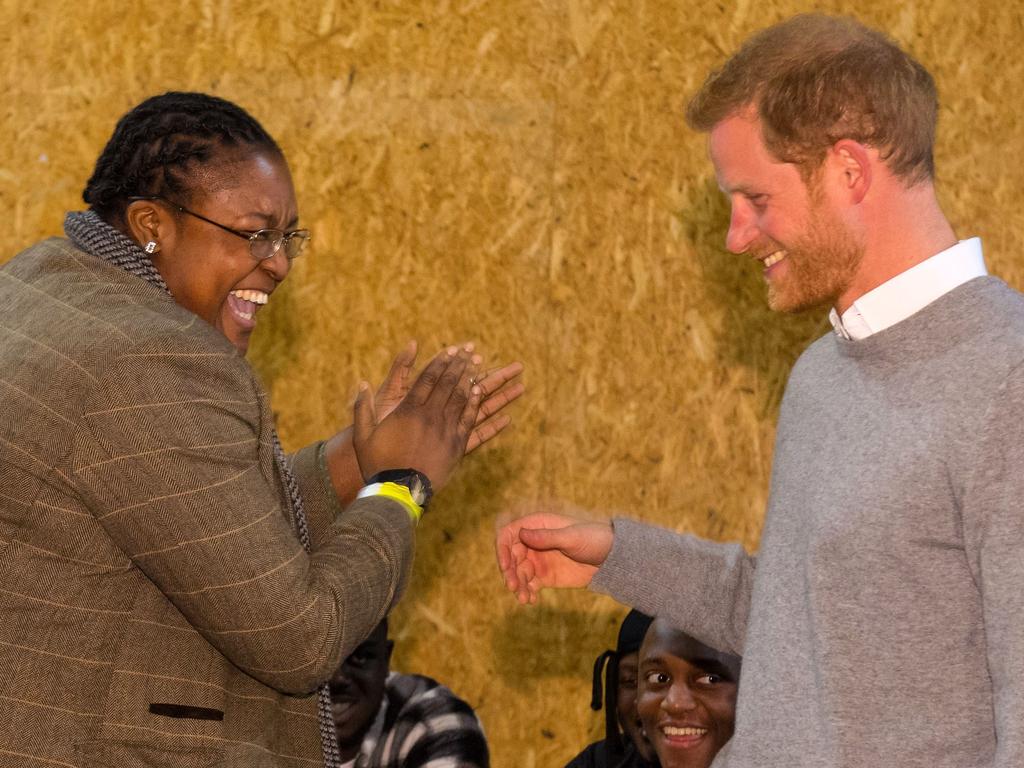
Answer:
686 13 938 185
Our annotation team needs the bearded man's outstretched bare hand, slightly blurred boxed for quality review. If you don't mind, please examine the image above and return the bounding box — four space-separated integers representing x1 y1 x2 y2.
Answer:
495 512 614 603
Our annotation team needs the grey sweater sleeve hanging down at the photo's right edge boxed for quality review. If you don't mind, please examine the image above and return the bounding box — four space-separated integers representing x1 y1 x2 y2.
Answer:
962 366 1024 768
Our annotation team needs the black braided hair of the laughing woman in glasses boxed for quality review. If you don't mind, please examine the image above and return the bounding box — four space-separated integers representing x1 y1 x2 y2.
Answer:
82 91 282 224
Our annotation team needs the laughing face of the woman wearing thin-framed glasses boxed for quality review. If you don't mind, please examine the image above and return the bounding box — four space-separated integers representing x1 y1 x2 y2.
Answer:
150 148 298 354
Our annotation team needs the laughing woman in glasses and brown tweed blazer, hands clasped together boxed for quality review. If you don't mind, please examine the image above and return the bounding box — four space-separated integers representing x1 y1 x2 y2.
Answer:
0 93 521 768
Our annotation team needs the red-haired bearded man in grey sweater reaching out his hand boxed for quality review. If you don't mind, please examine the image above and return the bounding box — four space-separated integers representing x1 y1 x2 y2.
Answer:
497 15 1024 768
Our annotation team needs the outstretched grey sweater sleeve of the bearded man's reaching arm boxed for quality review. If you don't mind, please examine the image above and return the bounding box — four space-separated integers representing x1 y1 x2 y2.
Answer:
591 518 756 655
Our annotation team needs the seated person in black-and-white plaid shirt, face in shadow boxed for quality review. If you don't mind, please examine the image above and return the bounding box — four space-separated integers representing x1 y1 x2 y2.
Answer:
330 618 490 768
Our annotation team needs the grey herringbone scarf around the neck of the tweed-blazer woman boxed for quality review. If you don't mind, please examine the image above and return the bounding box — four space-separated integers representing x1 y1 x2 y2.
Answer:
65 211 341 768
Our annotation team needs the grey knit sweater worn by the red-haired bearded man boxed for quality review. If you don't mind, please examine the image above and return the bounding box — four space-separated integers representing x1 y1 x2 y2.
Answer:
592 278 1024 768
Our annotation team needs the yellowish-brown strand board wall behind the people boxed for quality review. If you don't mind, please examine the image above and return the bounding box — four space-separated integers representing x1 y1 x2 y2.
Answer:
0 0 1024 768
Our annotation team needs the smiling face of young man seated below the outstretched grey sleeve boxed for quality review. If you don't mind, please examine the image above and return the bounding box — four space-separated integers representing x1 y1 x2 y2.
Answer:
637 618 739 768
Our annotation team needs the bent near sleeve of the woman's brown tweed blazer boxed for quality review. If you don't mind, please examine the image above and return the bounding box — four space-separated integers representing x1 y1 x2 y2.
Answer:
73 334 413 693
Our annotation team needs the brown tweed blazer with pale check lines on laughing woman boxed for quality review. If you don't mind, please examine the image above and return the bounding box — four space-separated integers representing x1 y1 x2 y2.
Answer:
0 239 413 768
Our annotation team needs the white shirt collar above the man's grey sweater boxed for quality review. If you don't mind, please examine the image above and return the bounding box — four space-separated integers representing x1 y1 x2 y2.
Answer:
828 238 988 341
